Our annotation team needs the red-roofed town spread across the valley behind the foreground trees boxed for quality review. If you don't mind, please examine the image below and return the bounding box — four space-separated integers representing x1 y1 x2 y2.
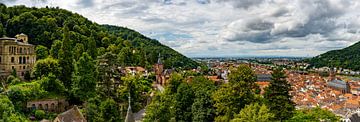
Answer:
194 57 360 118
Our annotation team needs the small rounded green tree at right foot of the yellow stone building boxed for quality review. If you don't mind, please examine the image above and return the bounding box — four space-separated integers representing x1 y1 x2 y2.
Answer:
33 57 60 78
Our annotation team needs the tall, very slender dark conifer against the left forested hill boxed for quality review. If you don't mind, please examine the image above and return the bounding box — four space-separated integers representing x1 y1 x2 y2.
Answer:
59 23 74 89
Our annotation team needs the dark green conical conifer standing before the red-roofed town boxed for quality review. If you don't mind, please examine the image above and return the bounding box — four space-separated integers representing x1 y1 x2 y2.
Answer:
264 68 295 121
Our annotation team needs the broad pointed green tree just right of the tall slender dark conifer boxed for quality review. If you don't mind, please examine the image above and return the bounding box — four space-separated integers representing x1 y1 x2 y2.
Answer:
72 52 96 101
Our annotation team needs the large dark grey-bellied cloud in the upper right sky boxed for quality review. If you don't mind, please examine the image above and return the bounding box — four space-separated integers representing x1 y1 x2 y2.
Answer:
224 0 353 43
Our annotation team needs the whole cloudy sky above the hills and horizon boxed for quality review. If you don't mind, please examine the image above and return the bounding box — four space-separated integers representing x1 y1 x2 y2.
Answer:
0 0 360 57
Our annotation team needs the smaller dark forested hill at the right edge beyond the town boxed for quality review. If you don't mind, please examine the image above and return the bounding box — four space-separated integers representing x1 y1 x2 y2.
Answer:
307 42 360 70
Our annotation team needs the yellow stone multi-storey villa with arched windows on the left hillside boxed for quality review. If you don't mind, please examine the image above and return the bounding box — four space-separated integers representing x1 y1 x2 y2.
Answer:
0 34 36 78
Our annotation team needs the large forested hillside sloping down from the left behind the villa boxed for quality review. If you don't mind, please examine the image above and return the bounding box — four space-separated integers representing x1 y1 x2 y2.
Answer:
0 3 198 68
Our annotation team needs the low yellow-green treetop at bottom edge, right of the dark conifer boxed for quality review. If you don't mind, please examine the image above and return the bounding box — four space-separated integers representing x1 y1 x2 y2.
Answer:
288 107 340 122
